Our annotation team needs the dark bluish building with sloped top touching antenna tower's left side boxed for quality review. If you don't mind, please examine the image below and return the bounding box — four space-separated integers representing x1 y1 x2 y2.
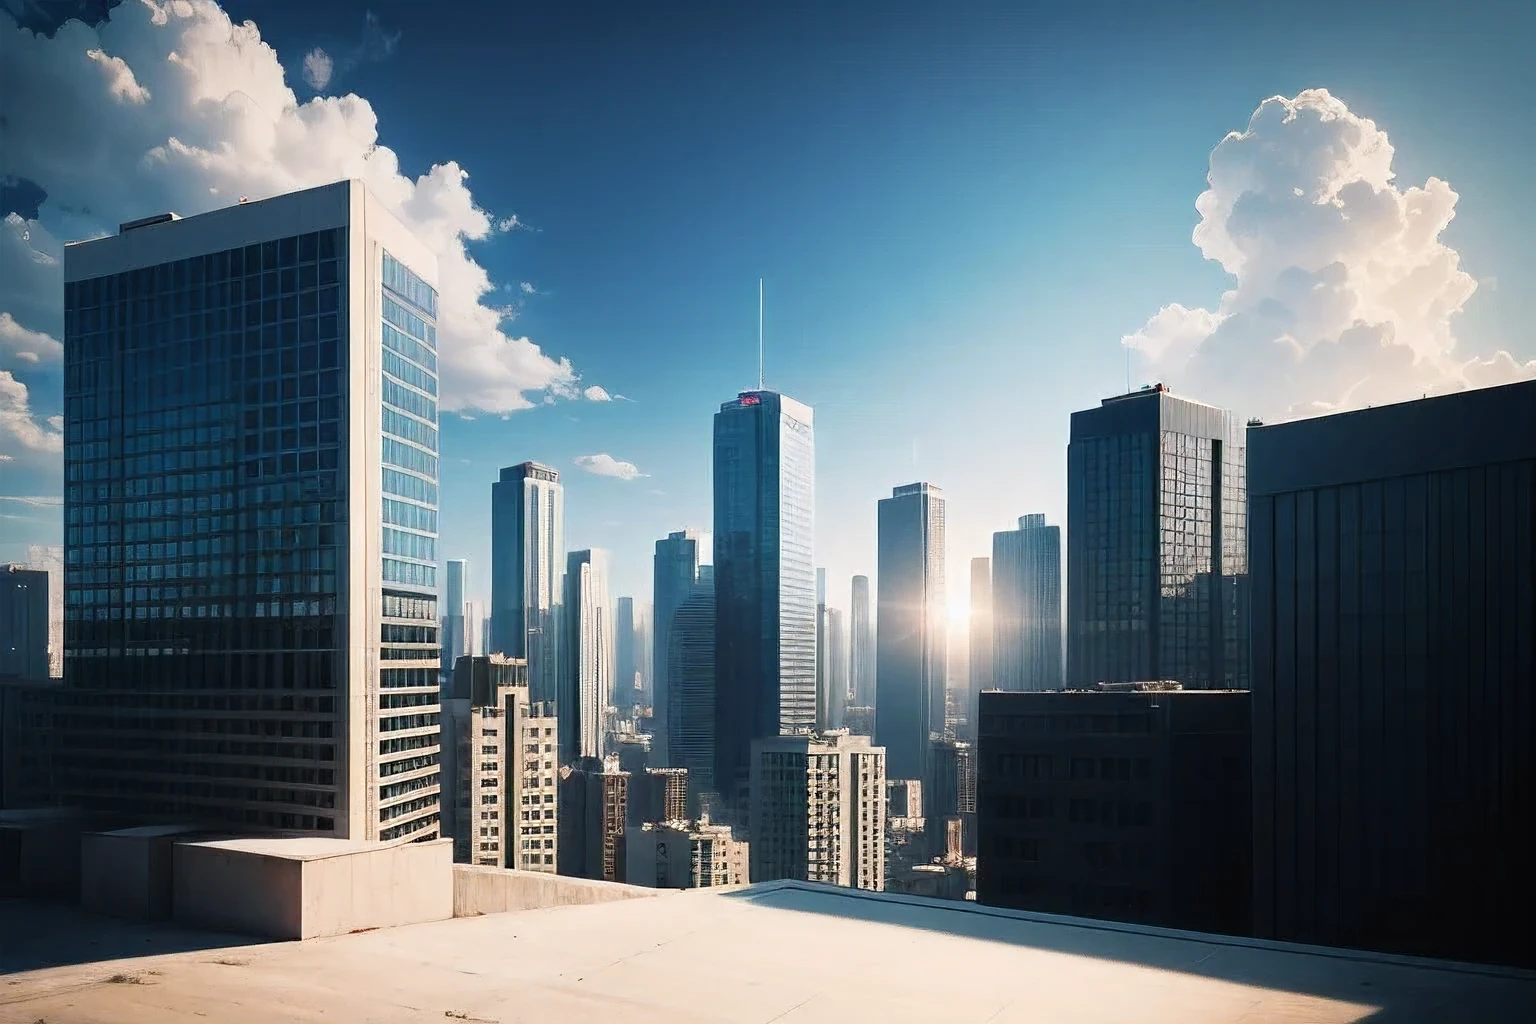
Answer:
667 565 716 789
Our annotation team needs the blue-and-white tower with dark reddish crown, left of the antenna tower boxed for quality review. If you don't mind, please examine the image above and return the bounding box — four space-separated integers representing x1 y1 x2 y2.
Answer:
487 462 570 706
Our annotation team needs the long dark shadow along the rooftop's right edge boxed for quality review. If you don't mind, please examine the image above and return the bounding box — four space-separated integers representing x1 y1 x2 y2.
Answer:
720 883 1536 1024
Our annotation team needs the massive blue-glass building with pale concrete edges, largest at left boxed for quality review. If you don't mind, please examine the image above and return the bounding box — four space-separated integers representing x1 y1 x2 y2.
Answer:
58 181 439 840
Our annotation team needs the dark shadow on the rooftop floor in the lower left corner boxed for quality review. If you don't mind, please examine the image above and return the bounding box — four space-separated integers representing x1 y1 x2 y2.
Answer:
0 900 263 976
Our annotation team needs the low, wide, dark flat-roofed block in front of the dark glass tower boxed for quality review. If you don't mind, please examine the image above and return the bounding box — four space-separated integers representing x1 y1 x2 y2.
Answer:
977 682 1252 935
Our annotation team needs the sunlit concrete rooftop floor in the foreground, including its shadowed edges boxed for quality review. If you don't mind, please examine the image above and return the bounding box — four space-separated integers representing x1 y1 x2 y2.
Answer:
0 883 1536 1024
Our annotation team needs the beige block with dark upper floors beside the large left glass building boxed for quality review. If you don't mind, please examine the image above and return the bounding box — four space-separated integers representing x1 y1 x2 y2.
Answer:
442 654 559 874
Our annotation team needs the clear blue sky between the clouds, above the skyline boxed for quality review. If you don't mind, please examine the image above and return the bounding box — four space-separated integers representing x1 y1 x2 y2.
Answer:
0 0 1536 605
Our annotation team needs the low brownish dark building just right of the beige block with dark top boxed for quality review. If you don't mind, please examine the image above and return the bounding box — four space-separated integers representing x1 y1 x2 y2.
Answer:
558 755 630 881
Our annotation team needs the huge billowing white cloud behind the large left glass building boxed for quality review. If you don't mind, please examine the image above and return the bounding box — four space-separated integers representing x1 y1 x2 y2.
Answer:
0 0 579 413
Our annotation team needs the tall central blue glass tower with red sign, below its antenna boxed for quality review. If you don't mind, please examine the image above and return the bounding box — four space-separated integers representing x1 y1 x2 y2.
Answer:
714 391 816 806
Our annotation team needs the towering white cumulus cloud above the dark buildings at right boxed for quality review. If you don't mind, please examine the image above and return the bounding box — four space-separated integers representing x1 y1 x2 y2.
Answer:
1124 89 1536 416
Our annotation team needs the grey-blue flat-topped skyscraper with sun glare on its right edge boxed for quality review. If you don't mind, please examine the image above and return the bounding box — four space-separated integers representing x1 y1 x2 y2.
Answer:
874 484 948 780
